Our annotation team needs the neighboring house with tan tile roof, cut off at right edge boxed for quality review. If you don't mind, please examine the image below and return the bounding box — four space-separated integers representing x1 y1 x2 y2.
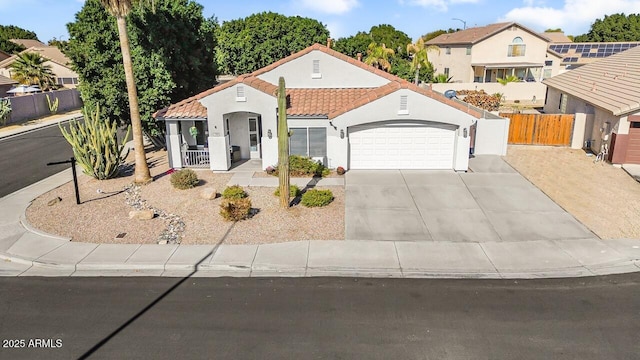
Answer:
544 46 640 164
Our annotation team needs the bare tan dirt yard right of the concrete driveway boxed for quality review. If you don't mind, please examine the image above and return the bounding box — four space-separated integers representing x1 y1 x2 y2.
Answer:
505 145 640 239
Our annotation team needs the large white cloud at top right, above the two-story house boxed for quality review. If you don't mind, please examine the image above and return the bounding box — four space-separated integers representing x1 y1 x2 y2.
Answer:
499 0 640 35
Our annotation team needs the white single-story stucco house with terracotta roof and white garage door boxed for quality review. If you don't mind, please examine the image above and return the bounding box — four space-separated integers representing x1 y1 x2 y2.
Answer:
154 44 508 171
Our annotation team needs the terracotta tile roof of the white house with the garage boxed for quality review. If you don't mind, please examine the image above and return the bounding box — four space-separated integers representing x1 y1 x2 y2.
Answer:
153 44 483 119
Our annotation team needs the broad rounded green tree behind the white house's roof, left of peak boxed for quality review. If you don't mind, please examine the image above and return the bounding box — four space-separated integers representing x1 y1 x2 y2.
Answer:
216 12 329 75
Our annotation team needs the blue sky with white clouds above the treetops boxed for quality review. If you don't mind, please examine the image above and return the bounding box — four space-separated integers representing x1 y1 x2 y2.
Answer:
0 0 640 42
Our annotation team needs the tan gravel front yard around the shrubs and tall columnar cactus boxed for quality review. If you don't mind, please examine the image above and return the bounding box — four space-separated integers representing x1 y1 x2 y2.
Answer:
27 151 344 244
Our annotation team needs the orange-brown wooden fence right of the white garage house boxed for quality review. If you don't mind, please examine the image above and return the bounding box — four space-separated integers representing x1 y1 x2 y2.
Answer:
500 113 574 146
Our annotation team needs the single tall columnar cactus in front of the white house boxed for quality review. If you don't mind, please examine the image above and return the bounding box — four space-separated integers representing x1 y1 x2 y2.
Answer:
278 76 290 208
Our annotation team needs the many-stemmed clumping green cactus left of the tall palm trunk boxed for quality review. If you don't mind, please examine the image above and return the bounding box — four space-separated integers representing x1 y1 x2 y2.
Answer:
58 106 131 180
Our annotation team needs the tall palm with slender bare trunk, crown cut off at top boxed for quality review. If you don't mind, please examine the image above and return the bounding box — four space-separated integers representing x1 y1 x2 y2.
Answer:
100 0 152 184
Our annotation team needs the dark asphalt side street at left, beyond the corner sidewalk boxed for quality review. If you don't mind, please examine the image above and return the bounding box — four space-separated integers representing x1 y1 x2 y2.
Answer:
0 124 73 197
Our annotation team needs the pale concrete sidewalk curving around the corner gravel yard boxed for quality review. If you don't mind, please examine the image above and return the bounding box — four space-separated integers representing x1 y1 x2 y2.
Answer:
0 170 640 278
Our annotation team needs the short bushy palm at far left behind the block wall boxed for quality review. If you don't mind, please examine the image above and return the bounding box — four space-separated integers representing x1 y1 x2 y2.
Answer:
10 52 55 90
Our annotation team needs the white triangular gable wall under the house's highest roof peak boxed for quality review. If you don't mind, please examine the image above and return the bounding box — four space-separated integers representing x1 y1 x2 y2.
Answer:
258 50 389 88
